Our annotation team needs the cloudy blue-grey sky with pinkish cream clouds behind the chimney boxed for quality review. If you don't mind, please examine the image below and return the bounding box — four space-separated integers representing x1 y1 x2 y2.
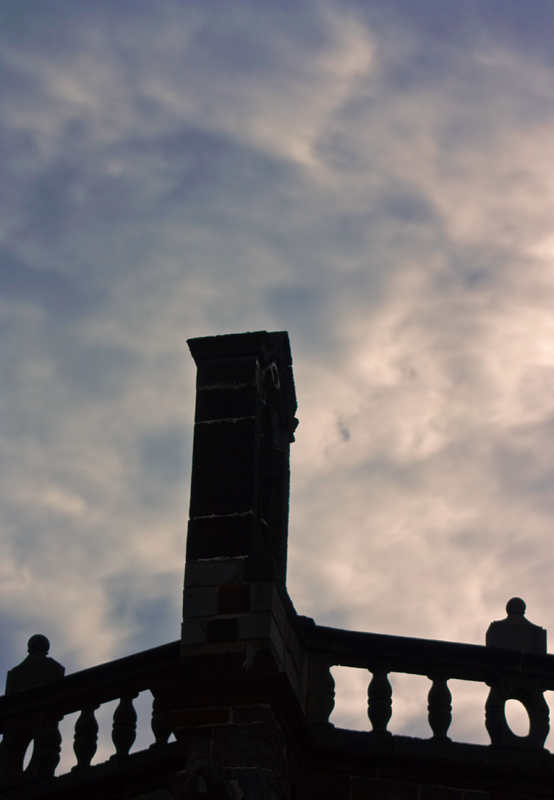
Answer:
0 0 554 756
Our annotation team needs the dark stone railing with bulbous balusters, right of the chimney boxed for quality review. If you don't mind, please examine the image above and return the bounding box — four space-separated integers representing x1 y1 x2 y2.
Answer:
303 620 554 753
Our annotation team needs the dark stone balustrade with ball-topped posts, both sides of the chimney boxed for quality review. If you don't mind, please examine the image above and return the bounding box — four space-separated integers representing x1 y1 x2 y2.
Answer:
4 601 554 797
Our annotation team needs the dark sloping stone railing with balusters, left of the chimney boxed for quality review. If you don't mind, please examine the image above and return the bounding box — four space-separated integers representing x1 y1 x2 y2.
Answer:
0 637 180 791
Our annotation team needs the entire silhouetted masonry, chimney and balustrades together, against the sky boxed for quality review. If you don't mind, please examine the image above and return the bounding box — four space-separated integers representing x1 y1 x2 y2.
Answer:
0 331 554 800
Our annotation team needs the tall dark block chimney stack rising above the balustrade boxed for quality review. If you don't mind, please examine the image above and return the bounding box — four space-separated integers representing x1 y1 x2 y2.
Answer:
182 331 297 647
